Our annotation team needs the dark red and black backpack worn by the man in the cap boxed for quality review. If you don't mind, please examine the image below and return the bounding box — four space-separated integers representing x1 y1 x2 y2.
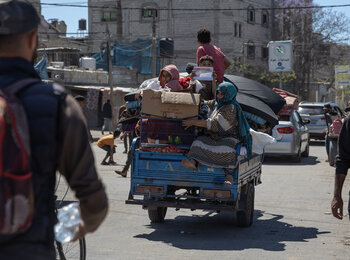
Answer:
0 79 39 237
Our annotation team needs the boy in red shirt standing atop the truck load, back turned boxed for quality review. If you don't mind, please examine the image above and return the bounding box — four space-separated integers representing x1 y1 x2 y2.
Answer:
197 29 231 84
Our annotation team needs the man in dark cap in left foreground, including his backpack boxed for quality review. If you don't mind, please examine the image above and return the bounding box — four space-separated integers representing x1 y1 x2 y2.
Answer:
0 0 108 260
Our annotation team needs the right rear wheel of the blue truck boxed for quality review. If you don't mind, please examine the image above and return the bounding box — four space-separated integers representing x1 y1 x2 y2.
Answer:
237 183 255 227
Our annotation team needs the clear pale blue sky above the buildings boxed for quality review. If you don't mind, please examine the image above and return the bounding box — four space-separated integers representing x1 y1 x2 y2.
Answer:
41 0 350 36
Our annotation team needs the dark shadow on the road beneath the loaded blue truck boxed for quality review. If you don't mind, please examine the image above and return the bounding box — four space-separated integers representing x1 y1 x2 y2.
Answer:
135 210 329 251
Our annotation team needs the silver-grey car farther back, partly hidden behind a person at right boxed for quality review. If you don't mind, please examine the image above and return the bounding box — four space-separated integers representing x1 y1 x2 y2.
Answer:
298 102 344 140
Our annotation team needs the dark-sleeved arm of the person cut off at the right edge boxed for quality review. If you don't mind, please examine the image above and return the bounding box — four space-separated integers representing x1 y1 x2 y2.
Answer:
331 115 350 219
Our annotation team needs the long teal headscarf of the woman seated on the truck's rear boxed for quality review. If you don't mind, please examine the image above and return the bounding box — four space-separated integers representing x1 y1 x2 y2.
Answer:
215 82 252 157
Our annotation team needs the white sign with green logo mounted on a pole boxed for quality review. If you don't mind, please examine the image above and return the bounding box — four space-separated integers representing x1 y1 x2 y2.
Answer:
268 41 293 72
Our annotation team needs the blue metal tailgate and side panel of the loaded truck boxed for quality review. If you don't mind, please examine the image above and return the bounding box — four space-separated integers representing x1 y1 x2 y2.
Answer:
129 146 261 204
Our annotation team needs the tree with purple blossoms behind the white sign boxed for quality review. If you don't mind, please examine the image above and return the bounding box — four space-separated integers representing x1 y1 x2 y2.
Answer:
241 0 350 100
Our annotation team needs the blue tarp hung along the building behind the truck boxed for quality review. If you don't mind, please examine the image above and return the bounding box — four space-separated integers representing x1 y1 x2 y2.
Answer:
92 39 160 74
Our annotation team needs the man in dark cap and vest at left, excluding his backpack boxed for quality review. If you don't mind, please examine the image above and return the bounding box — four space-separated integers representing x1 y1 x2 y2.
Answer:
0 0 108 260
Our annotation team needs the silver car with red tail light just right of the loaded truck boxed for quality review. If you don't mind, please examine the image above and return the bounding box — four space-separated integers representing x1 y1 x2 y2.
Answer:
264 110 310 162
